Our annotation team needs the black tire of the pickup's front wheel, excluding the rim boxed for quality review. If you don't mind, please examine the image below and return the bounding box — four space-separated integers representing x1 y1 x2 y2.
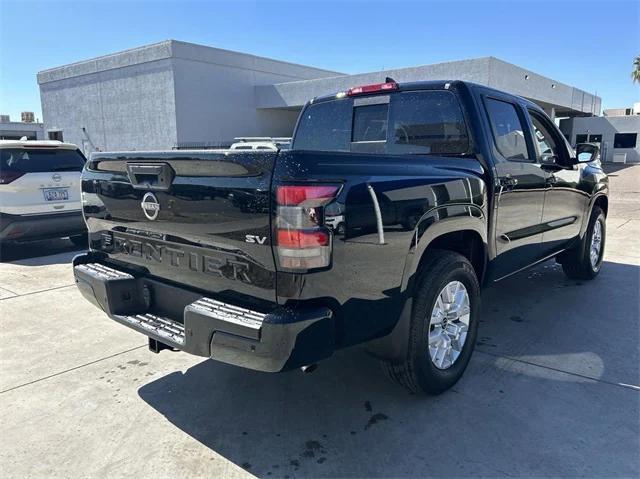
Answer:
558 206 607 280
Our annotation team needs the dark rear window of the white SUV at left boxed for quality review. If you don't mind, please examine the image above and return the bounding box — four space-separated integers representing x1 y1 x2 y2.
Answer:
0 148 84 173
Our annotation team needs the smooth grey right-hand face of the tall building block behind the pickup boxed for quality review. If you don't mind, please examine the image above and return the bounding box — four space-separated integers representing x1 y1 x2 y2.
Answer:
173 42 336 146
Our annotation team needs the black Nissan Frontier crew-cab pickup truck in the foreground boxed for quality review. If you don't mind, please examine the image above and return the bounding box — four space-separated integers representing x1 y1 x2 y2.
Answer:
73 79 608 394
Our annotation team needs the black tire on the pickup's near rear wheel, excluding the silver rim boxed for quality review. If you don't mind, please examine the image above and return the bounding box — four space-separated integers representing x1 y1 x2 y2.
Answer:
383 250 480 394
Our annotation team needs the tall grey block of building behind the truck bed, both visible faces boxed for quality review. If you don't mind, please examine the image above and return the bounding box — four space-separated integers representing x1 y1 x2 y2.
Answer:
38 40 338 154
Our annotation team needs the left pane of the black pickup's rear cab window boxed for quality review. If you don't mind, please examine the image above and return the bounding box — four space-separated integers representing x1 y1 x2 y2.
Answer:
294 100 353 151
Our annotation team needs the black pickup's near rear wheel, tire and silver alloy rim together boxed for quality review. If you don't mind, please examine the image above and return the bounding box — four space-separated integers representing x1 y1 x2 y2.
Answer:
383 250 480 394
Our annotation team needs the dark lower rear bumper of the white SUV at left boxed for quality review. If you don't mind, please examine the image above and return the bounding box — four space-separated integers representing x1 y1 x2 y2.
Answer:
0 210 87 241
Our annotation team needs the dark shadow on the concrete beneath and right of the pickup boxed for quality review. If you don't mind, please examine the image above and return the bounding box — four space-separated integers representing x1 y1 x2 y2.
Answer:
138 262 640 478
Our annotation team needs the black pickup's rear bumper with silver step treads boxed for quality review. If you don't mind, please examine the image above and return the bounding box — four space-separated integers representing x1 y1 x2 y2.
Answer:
73 252 335 372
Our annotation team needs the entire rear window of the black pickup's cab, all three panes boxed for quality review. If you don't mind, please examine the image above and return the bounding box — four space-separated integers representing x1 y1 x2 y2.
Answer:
294 90 469 155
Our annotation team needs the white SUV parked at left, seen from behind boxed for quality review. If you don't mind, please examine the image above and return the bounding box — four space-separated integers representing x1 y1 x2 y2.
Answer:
0 140 87 245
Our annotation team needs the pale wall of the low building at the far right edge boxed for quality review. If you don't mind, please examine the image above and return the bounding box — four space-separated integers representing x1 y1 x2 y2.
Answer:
560 116 640 163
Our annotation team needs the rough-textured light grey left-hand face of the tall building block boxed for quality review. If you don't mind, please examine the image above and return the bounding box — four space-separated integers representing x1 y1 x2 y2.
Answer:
38 44 177 154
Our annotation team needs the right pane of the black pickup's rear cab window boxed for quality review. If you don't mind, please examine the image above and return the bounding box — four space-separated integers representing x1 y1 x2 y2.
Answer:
387 91 469 154
